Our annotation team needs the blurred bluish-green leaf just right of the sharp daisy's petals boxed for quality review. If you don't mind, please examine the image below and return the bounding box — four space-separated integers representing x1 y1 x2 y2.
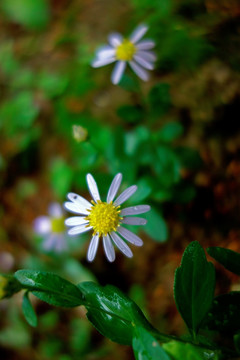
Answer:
144 207 168 242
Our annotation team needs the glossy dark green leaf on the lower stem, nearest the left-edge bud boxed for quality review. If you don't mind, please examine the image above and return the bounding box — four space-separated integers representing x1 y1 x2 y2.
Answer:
14 270 83 307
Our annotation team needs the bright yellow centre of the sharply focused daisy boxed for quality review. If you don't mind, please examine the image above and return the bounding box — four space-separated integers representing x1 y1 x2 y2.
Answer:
85 200 122 236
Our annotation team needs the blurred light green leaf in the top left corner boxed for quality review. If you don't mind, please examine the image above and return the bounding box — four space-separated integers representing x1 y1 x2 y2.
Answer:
1 0 50 29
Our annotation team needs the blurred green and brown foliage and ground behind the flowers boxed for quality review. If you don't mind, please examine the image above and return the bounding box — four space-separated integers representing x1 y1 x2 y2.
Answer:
0 0 240 360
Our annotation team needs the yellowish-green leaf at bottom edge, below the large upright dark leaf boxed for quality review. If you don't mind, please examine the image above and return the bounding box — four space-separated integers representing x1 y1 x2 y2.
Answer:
162 341 218 360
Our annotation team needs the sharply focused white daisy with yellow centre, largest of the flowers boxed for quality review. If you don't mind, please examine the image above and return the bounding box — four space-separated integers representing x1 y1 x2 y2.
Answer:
64 173 150 262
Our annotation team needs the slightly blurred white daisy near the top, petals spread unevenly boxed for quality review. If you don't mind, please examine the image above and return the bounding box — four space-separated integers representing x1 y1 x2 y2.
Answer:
92 24 156 84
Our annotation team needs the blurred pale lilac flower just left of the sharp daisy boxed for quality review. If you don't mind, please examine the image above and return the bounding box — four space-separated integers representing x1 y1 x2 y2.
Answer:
33 203 67 252
